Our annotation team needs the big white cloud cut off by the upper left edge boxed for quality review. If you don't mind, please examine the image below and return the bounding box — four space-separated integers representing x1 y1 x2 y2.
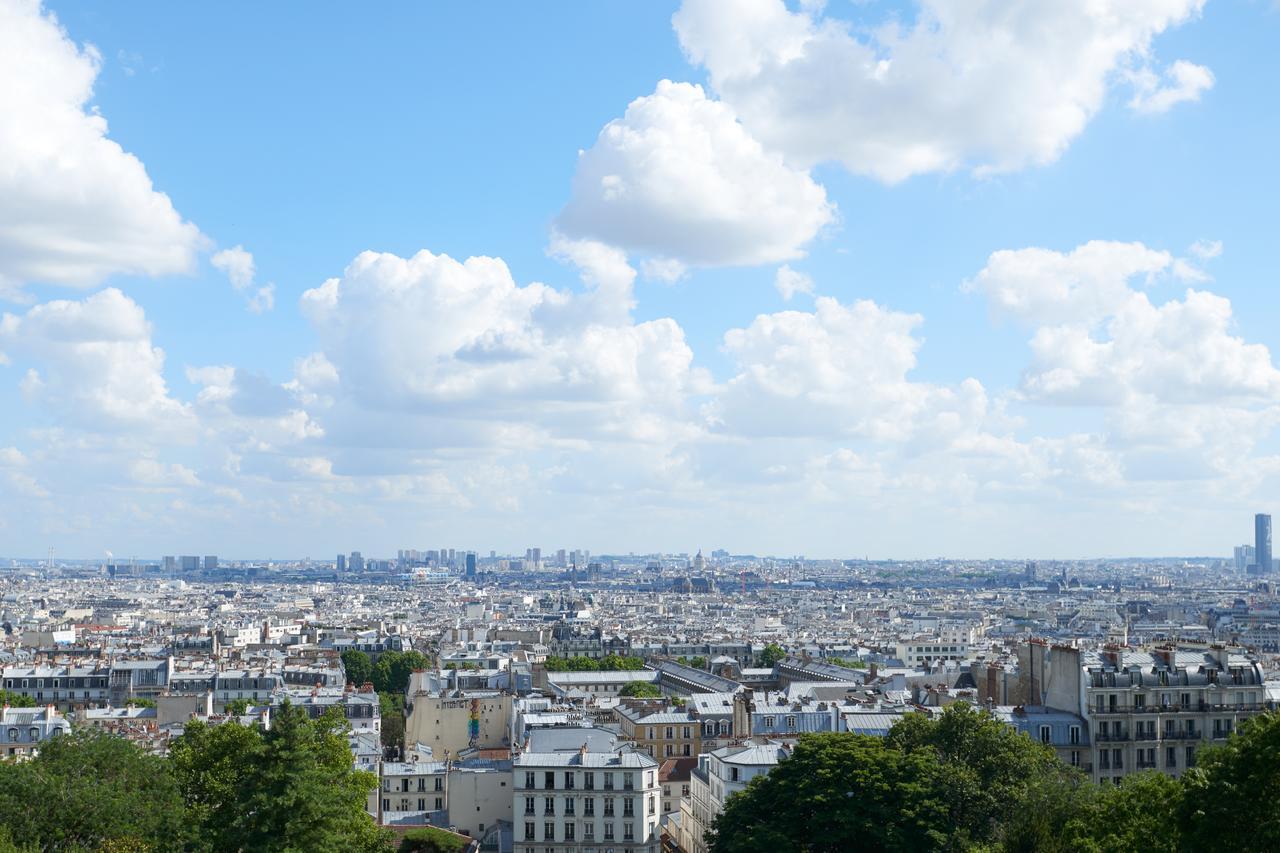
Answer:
0 0 205 298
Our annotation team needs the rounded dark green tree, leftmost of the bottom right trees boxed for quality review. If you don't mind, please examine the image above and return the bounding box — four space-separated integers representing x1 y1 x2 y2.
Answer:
708 733 950 853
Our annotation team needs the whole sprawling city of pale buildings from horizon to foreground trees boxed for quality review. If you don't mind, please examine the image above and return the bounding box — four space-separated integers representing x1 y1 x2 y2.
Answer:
0 516 1280 853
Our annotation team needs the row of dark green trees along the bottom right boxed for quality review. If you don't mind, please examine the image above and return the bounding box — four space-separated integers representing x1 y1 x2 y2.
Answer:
709 703 1280 853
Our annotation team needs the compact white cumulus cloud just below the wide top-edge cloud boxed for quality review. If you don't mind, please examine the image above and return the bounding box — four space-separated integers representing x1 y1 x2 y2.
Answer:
557 81 835 266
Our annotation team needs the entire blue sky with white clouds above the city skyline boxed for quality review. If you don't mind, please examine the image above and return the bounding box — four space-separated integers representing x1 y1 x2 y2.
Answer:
0 0 1280 557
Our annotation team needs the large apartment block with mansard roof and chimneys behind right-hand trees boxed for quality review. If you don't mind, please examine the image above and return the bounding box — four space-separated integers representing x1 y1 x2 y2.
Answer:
1018 640 1268 783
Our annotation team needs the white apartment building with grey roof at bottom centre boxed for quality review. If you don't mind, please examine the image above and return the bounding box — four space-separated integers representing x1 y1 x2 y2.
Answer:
512 745 662 853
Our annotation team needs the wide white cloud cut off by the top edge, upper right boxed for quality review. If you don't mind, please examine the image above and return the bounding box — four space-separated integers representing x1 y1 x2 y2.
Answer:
673 0 1213 182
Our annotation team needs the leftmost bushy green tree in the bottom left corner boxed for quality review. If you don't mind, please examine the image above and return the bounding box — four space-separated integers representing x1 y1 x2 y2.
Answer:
0 730 188 850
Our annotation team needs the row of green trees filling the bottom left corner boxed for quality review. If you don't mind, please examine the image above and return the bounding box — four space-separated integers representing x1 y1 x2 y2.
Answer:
0 704 390 853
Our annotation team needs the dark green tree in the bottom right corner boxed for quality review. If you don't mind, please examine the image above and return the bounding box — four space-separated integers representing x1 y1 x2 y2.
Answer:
1179 711 1280 852
